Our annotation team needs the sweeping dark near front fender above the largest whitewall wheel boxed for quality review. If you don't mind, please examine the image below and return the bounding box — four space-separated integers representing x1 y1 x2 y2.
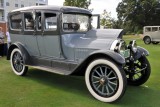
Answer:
71 50 126 75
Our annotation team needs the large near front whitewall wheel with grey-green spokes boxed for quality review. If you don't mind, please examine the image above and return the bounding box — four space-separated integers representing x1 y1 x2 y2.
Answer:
85 59 127 102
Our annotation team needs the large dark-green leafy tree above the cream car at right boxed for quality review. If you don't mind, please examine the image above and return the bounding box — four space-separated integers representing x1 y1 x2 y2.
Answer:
117 0 160 32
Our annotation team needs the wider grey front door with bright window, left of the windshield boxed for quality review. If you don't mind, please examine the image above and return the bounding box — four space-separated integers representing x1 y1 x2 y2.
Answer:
37 11 60 59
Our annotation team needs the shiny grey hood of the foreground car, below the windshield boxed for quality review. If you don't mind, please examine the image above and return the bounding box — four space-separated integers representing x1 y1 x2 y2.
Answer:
62 29 123 50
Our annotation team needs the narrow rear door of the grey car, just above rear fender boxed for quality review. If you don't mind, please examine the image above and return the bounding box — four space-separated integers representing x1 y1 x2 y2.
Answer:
22 11 40 56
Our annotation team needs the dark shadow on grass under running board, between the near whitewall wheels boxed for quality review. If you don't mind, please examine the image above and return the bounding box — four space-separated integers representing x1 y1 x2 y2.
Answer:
26 69 88 95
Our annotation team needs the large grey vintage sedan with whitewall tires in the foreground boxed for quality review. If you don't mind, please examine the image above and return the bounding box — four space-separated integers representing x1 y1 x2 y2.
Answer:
7 6 151 102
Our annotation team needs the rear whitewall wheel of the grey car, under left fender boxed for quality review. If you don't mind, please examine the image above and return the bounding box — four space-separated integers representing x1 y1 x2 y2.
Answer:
10 48 28 76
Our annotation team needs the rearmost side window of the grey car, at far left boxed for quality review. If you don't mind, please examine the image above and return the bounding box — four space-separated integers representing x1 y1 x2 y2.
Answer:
10 14 22 30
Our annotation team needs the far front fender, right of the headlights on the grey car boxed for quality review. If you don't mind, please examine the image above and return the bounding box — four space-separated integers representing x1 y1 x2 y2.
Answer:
134 46 149 60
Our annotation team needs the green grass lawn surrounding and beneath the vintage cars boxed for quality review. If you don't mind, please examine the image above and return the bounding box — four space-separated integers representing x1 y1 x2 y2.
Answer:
0 36 160 107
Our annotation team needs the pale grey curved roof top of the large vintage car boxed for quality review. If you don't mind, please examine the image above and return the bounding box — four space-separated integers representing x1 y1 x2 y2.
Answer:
11 5 92 15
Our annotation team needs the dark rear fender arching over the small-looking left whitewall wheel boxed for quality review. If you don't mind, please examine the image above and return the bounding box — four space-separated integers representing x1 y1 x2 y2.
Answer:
7 43 32 65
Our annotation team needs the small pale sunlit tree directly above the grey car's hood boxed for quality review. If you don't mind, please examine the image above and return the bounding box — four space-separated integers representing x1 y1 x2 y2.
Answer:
100 10 112 28
